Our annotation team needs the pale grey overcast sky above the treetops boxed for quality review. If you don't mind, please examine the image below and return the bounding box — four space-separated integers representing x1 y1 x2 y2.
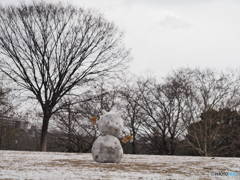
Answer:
0 0 240 76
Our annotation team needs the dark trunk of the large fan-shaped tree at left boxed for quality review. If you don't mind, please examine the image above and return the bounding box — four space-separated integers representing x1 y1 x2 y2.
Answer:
40 115 51 152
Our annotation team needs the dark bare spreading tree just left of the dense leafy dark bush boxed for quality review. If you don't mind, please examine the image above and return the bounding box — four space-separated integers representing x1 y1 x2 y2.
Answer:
136 75 189 154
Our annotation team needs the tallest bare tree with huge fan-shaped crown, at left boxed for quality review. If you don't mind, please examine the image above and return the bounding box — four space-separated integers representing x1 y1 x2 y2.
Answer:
0 2 129 151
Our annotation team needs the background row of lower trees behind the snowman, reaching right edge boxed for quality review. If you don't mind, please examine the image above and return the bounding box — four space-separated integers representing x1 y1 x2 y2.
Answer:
43 68 240 156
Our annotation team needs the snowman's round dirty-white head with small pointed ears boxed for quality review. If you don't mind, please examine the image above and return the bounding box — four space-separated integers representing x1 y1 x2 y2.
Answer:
98 110 124 137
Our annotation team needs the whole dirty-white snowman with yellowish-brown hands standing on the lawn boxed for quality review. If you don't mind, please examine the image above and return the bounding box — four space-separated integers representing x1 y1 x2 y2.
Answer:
91 110 132 163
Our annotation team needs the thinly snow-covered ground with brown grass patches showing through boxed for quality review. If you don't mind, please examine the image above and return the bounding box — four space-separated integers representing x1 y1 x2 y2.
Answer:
0 151 240 180
